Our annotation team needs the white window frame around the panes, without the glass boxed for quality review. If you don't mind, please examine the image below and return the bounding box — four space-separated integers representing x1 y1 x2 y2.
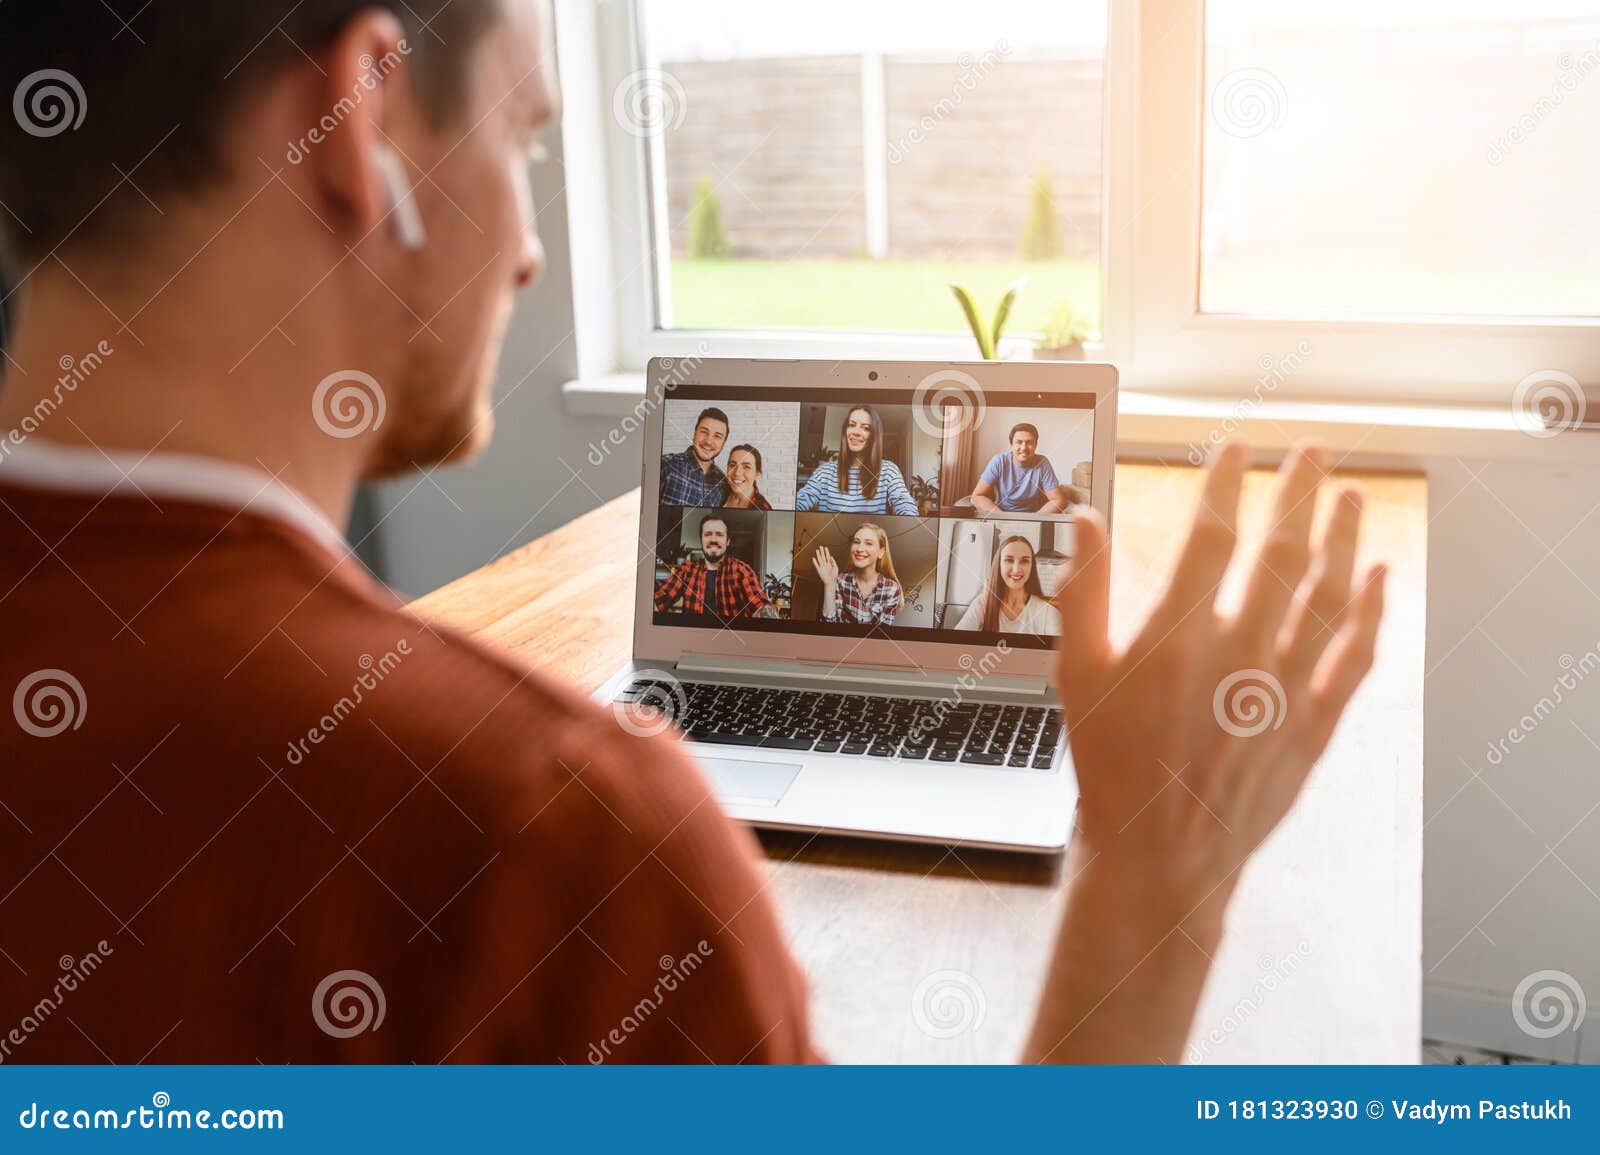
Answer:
557 0 1600 406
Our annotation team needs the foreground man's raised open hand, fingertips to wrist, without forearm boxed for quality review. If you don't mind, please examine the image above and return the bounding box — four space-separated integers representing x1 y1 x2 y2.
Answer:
1056 443 1384 894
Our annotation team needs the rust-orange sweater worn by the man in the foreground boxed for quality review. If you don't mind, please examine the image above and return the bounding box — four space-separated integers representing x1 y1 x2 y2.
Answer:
0 485 811 1064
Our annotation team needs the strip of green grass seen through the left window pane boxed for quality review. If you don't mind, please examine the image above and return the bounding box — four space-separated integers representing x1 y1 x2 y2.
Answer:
670 259 1101 336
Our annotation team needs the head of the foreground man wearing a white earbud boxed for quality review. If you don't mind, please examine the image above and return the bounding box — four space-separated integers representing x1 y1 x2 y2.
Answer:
0 0 555 475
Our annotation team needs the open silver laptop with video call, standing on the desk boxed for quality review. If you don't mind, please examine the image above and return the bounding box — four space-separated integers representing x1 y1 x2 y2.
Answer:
598 357 1117 853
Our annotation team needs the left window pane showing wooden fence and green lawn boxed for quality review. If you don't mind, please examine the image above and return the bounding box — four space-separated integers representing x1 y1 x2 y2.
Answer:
619 0 1106 333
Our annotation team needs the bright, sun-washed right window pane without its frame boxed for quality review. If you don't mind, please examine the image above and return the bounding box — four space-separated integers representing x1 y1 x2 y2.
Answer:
1200 0 1600 317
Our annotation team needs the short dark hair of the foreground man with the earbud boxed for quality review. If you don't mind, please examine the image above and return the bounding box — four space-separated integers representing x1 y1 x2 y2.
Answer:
0 0 502 262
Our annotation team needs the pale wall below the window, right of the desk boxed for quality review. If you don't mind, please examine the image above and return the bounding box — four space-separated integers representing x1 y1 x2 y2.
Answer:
1422 451 1600 1062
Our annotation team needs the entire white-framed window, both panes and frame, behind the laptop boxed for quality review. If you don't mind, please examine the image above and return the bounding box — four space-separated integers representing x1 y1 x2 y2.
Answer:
576 0 1600 405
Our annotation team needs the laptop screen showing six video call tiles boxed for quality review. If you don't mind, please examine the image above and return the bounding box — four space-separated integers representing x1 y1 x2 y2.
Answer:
653 386 1109 648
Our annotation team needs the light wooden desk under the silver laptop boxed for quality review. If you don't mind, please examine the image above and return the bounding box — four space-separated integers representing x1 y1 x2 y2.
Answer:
413 464 1427 1062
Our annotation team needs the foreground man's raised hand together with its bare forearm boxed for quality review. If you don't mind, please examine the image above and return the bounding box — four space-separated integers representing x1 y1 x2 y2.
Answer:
1027 443 1384 1062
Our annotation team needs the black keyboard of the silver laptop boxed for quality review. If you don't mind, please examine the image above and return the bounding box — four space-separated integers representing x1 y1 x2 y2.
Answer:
618 678 1061 769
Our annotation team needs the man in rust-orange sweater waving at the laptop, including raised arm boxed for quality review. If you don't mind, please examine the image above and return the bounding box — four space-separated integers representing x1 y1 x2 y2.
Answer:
0 0 1382 1064
